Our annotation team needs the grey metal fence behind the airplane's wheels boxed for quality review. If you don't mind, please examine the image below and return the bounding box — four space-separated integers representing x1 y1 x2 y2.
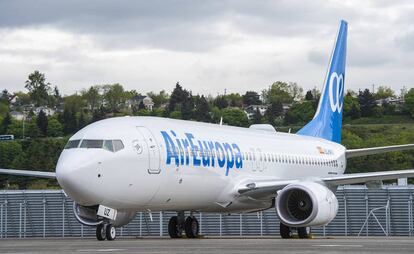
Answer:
0 185 414 238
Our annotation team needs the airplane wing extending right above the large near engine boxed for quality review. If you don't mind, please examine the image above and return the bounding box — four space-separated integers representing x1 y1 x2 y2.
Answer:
238 169 414 198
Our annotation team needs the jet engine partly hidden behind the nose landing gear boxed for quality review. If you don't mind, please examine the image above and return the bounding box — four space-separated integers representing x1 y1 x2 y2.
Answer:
73 202 136 227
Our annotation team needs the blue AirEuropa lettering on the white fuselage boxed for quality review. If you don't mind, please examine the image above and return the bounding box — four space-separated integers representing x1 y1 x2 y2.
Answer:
161 130 243 176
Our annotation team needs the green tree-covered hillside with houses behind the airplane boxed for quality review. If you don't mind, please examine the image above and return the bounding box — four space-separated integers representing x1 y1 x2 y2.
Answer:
0 71 414 189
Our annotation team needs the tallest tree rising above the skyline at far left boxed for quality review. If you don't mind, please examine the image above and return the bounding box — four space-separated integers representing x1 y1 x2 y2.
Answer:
25 71 50 106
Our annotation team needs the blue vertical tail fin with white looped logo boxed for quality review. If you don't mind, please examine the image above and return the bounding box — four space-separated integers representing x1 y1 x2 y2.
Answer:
297 20 348 143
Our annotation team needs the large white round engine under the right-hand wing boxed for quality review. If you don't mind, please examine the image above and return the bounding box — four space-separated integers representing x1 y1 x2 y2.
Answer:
276 182 338 227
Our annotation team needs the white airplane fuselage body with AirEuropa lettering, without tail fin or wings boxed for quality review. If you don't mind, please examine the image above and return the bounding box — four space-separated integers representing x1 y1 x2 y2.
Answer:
56 117 346 212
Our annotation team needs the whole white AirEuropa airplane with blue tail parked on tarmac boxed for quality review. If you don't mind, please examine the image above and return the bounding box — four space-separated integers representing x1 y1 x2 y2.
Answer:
0 21 414 240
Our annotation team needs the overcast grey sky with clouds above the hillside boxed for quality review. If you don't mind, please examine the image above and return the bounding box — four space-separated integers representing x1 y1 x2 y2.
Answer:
0 0 414 95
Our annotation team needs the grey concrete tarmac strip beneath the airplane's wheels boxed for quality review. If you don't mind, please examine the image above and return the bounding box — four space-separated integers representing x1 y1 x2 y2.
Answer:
0 237 414 254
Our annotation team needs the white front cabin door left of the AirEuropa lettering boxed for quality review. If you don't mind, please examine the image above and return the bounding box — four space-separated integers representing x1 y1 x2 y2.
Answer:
137 126 161 174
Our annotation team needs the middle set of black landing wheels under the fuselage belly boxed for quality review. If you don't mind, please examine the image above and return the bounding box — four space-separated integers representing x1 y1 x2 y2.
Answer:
168 212 200 238
